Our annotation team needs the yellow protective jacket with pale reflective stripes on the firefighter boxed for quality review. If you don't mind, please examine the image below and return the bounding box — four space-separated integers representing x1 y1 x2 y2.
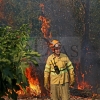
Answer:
44 53 74 84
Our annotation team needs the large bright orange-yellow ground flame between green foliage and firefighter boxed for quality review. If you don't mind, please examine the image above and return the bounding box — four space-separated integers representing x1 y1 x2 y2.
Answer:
16 66 41 96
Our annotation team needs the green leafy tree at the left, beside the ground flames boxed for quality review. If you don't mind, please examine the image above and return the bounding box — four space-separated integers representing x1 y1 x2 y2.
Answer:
0 25 40 100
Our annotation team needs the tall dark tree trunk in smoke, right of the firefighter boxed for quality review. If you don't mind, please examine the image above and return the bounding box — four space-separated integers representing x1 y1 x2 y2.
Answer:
81 0 90 88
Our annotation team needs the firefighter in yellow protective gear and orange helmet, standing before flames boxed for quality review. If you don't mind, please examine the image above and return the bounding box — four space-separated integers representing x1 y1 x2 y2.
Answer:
44 40 75 100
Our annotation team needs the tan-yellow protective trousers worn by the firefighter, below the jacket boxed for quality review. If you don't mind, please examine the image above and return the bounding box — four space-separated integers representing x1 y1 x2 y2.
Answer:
50 82 70 100
